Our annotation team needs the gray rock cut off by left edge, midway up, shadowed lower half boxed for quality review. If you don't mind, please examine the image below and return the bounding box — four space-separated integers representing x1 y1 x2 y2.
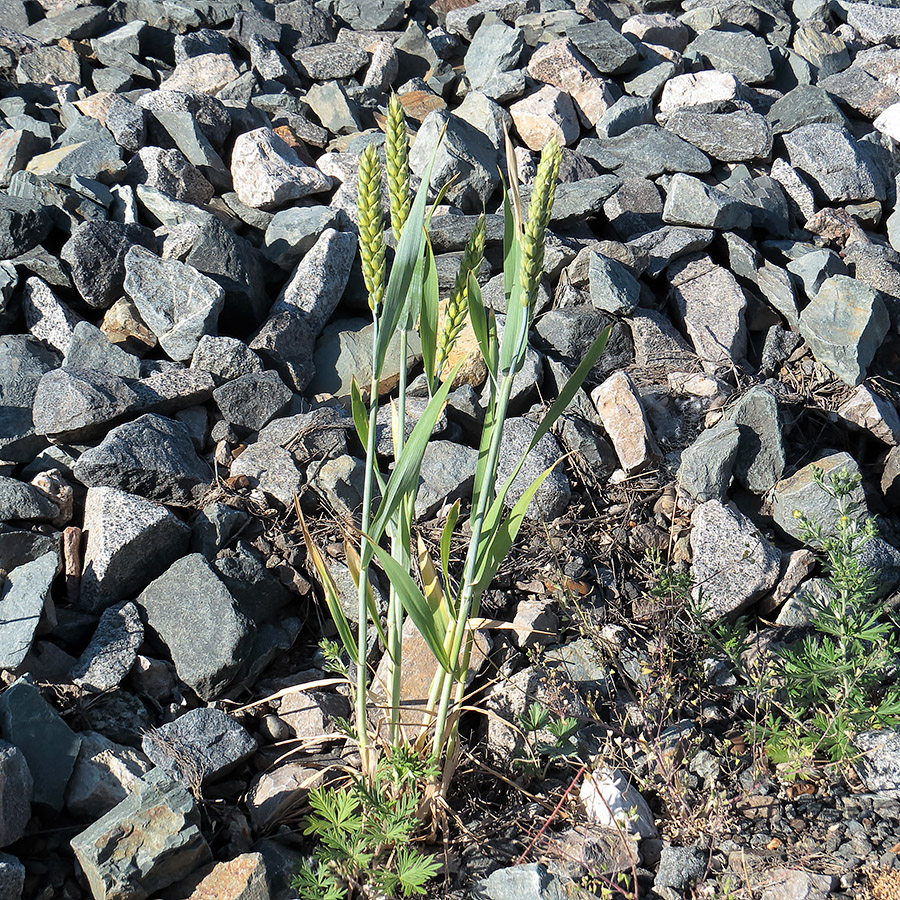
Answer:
0 334 59 462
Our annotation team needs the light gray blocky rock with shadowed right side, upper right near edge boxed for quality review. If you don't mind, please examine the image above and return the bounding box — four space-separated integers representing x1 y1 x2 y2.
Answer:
784 123 884 202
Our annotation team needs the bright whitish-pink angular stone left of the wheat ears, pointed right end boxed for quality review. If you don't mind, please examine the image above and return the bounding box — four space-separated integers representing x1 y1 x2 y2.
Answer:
231 128 331 209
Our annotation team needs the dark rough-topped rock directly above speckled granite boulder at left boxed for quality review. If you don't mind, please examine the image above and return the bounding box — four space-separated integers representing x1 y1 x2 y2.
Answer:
74 413 212 506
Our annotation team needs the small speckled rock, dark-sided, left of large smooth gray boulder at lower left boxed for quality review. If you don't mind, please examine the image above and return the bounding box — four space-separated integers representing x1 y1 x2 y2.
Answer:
71 603 144 691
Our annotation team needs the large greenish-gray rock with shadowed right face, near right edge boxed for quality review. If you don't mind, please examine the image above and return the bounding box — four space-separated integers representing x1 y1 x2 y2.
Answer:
799 275 890 385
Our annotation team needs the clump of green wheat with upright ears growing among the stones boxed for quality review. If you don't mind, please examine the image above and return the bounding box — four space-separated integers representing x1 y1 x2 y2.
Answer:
298 109 608 797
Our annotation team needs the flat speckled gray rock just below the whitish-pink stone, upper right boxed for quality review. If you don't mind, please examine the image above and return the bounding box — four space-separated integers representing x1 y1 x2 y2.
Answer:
665 108 772 162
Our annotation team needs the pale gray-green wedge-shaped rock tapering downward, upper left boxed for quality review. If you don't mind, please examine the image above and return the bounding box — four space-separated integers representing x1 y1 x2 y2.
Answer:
125 246 225 360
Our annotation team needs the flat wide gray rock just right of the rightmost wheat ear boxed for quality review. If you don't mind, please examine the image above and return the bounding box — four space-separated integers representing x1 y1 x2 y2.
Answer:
578 125 712 178
